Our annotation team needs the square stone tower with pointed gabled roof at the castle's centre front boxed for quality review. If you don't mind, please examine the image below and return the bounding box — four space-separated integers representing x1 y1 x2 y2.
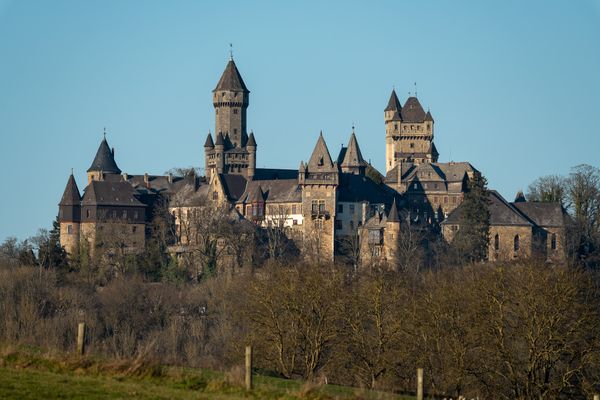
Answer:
298 133 340 262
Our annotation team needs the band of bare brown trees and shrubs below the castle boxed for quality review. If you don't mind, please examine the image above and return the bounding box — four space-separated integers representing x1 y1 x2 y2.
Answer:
0 262 600 399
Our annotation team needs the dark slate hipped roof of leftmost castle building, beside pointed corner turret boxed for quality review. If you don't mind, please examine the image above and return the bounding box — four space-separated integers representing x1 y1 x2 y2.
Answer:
81 181 146 207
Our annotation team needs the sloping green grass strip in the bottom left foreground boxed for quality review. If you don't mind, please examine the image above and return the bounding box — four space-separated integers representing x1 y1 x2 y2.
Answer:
0 350 411 400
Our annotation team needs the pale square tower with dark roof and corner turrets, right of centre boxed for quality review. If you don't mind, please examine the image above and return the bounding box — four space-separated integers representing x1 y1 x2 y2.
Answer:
384 90 439 172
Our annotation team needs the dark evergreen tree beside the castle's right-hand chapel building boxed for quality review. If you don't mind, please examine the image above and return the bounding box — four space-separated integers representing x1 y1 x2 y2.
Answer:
452 175 490 263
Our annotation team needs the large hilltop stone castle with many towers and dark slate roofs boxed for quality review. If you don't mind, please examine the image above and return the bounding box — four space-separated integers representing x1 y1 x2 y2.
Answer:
59 54 564 263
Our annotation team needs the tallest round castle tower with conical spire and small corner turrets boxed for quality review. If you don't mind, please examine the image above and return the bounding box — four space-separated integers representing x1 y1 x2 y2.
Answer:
204 57 256 179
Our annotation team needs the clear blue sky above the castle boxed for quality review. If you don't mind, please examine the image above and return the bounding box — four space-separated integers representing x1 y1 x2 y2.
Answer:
0 0 600 240
